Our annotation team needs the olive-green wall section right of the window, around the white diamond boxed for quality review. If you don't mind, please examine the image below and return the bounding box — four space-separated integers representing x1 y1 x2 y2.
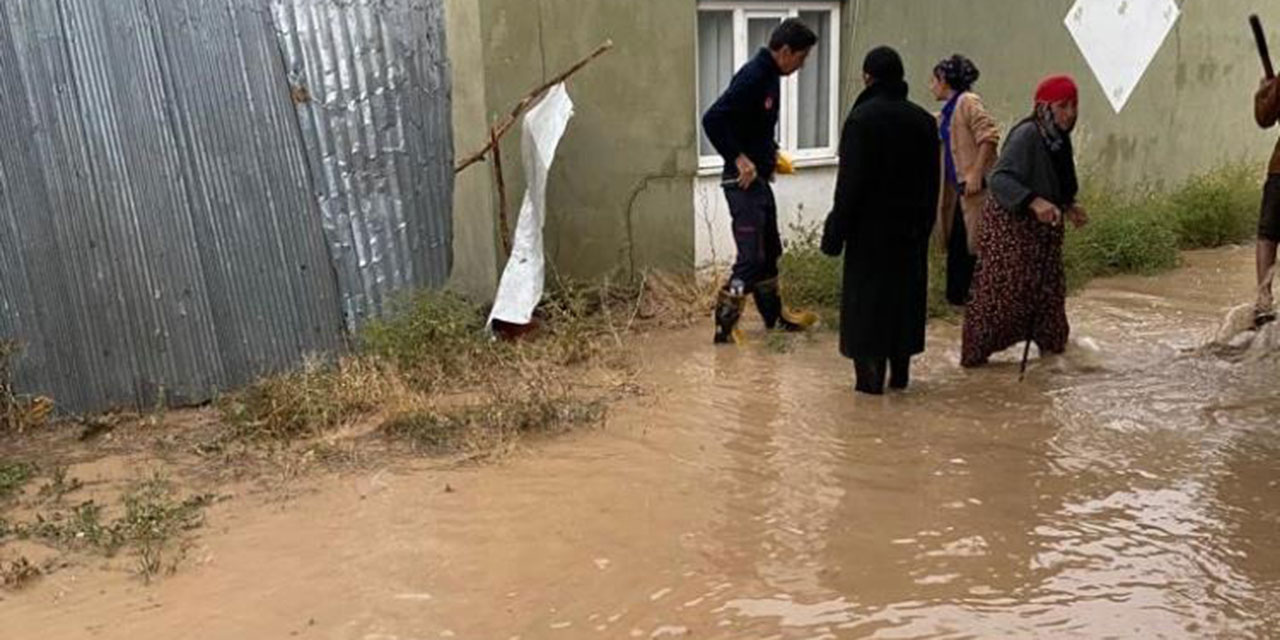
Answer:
842 0 1280 187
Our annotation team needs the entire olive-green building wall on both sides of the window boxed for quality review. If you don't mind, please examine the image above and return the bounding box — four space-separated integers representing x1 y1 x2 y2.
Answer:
447 0 1280 282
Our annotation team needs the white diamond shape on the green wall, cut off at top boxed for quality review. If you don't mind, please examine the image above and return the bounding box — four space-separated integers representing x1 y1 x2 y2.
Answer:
1066 0 1179 113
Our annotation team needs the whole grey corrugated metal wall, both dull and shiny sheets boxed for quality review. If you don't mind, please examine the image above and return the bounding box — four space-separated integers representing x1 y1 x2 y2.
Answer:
0 0 452 411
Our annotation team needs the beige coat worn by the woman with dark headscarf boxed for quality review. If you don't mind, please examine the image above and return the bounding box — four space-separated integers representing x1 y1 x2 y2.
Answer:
934 92 1000 255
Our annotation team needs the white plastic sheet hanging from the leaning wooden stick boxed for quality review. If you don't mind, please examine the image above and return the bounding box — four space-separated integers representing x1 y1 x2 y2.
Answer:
489 84 573 325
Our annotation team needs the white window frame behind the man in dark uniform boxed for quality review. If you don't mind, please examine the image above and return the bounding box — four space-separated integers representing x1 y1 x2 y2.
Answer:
694 0 841 173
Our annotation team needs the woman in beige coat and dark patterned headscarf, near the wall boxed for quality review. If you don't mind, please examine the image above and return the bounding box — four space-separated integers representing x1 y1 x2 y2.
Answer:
929 54 1000 305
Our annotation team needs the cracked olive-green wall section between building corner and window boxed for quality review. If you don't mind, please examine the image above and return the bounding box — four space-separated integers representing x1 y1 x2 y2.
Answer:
479 0 698 278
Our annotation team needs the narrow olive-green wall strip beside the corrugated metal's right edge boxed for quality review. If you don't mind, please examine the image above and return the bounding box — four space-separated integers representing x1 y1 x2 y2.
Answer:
444 0 498 302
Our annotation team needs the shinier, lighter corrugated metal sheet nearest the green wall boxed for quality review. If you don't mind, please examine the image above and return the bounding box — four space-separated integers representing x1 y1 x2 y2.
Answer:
271 0 453 324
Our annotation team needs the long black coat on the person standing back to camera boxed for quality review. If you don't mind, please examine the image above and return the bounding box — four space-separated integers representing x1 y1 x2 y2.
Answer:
823 82 942 357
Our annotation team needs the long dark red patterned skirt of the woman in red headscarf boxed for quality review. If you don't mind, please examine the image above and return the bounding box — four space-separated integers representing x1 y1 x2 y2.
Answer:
960 197 1070 367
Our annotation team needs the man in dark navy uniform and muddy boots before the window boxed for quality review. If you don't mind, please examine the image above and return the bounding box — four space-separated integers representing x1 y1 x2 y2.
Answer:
703 18 818 343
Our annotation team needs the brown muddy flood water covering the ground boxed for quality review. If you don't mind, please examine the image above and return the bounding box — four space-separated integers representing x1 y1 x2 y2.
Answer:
0 248 1280 640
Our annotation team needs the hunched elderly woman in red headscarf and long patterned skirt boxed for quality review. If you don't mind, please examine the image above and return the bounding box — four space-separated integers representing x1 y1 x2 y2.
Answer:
960 76 1088 367
